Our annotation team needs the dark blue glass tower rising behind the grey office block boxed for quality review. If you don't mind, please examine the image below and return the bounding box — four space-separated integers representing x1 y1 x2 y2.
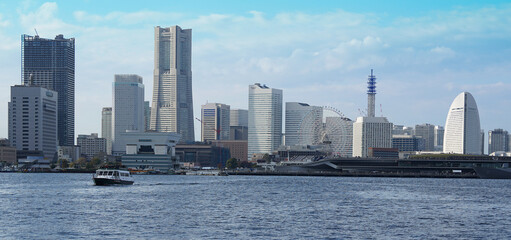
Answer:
21 35 75 146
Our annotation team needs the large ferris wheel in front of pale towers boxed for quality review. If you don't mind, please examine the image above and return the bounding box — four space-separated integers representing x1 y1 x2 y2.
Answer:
299 106 353 157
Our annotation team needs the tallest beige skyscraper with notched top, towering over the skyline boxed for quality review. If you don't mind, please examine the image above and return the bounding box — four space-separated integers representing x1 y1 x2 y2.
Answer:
151 26 195 141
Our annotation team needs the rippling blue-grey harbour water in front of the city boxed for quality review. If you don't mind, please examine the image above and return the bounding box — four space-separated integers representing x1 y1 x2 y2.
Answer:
0 173 511 239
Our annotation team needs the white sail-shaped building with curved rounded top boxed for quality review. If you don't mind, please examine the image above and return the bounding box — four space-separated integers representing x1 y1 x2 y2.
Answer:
444 92 482 154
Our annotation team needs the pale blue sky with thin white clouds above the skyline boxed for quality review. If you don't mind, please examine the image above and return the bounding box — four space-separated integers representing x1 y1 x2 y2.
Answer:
0 0 511 148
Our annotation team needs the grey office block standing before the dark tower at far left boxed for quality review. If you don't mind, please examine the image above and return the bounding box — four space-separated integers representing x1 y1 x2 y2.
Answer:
8 85 58 159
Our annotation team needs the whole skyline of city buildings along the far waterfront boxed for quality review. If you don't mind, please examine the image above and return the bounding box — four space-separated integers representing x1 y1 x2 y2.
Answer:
0 26 511 171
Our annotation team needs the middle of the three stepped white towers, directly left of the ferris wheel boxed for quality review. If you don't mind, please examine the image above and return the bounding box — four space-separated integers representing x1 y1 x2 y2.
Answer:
285 102 323 146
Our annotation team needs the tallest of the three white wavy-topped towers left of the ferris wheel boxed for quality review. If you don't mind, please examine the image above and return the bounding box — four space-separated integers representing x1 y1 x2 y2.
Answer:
248 83 282 159
